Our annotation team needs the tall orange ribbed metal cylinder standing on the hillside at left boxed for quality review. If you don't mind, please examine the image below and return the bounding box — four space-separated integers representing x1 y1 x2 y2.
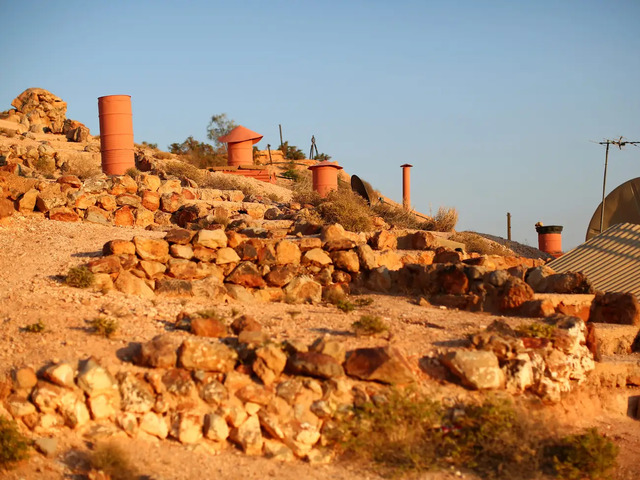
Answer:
98 95 136 175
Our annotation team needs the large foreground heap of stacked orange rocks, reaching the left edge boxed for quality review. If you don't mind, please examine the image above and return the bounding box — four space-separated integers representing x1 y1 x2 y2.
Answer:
0 317 415 462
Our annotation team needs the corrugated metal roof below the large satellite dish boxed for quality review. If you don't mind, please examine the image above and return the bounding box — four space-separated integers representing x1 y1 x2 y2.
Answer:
548 223 640 298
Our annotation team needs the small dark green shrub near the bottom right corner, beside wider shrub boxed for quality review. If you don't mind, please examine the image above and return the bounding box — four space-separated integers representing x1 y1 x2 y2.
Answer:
546 428 618 480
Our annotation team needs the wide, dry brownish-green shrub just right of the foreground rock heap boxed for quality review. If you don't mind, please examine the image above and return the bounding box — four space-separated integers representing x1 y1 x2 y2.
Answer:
327 391 546 480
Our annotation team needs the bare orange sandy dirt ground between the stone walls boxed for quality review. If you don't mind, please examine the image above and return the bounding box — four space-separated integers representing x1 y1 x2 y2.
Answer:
0 214 640 480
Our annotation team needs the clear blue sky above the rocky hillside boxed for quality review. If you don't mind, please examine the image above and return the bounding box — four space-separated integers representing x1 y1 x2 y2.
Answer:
0 0 640 248
